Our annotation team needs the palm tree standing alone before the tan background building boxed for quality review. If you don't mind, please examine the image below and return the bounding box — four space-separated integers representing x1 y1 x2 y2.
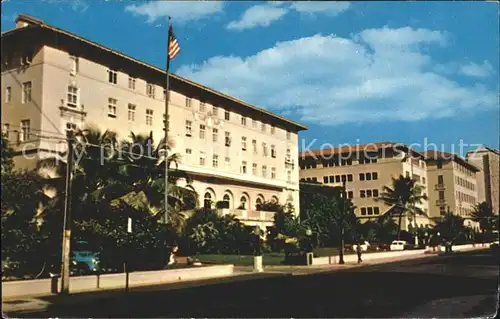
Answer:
376 175 427 240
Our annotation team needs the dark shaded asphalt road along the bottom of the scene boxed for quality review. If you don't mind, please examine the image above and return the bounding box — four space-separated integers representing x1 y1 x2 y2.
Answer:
5 251 500 318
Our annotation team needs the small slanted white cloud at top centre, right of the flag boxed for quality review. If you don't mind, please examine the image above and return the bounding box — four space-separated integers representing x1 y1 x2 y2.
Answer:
227 4 288 30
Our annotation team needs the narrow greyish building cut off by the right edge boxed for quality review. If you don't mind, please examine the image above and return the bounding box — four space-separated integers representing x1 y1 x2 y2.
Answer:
466 146 500 215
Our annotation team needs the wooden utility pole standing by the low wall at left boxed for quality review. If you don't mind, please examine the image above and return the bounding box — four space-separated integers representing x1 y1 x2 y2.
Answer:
61 130 73 294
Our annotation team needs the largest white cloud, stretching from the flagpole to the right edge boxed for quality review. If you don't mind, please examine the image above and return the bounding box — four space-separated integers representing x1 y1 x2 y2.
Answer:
178 27 498 125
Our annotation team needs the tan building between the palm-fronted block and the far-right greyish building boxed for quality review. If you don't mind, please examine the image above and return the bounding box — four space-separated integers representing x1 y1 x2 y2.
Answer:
424 151 479 226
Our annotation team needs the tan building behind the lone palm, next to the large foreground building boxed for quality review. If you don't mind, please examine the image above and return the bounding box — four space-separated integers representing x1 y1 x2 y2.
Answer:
299 142 430 229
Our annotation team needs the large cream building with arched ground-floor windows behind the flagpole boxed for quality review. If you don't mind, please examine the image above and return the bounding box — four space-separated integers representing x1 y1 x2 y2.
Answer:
2 15 307 231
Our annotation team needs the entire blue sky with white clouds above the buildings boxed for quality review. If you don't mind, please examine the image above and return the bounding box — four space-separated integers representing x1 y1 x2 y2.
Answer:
2 0 500 156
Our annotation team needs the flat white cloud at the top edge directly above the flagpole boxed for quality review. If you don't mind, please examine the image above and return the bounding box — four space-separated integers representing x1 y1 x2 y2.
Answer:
125 0 224 23
